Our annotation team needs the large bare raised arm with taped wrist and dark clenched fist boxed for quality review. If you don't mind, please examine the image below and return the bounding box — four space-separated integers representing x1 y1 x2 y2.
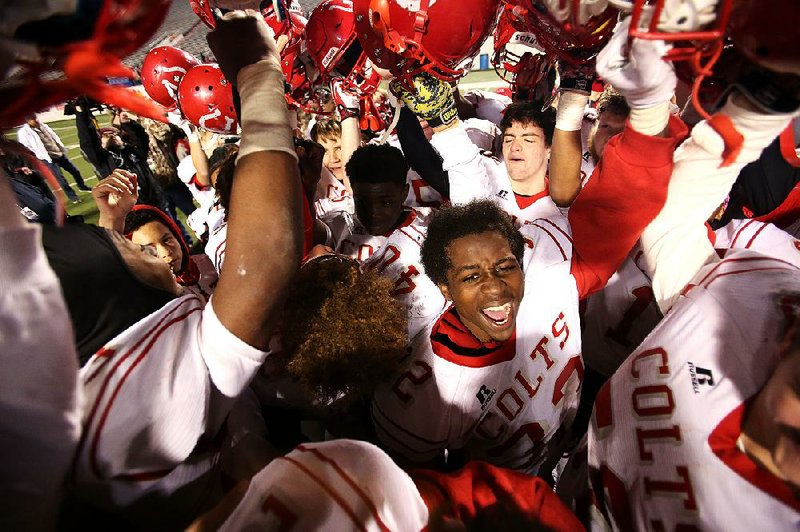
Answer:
208 11 303 349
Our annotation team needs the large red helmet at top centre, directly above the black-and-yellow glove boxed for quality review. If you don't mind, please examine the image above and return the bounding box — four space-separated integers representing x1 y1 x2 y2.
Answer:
354 0 500 84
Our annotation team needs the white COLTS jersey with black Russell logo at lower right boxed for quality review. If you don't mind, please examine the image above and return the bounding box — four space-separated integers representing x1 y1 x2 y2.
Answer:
589 249 800 530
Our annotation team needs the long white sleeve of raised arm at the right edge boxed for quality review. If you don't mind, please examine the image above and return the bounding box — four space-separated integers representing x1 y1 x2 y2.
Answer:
641 101 791 313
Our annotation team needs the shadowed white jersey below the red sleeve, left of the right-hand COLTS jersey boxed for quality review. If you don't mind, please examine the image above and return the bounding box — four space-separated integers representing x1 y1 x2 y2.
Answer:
582 247 661 377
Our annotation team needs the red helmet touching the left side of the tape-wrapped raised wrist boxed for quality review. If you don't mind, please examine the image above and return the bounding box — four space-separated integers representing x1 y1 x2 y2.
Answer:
178 64 238 135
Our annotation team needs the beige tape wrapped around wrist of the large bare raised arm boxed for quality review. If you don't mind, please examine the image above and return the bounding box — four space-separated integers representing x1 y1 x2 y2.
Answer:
236 58 297 161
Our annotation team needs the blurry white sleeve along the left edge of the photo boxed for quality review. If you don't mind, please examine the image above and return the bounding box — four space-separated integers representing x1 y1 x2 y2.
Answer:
0 224 79 530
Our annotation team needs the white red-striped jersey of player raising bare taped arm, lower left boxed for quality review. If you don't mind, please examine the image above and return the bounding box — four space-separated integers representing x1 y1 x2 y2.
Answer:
71 296 267 526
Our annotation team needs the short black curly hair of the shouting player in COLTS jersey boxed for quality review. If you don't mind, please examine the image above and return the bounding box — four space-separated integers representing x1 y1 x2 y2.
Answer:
420 200 525 285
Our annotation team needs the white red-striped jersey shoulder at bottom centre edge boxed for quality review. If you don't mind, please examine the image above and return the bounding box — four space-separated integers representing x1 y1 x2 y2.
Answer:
220 440 428 532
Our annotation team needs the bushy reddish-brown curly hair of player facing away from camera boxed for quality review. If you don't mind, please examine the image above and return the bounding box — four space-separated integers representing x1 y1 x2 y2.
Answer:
281 260 408 405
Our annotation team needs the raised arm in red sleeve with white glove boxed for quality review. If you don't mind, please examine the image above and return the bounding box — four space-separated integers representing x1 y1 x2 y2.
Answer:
569 21 687 297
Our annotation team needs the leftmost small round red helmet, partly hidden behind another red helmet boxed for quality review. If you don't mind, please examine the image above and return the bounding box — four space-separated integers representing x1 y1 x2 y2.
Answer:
141 46 200 110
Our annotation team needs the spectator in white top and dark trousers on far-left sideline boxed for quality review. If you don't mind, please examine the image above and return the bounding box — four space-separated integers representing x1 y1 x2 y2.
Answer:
17 115 91 203
